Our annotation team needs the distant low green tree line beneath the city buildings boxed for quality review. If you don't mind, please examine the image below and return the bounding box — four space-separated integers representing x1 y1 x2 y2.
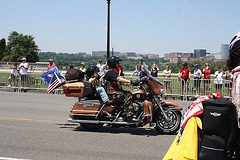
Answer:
38 52 227 73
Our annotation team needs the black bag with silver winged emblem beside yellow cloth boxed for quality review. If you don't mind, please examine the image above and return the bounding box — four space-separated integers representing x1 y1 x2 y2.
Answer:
198 97 238 160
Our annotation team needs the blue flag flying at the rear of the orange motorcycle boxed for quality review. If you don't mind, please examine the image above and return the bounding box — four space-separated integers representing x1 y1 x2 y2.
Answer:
40 67 65 85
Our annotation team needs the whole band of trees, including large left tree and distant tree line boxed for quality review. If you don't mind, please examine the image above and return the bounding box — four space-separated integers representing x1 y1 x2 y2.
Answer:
0 31 227 73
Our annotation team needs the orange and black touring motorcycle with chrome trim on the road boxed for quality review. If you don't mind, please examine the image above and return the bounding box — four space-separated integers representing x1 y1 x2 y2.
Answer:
64 63 182 134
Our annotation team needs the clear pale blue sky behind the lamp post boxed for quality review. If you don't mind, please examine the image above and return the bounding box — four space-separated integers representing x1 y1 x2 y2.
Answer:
0 0 240 55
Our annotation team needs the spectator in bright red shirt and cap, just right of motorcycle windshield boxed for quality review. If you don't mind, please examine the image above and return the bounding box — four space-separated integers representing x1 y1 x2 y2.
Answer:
178 63 191 95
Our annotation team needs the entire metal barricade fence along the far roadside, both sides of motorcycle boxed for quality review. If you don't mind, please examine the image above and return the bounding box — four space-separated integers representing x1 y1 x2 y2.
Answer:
0 72 231 101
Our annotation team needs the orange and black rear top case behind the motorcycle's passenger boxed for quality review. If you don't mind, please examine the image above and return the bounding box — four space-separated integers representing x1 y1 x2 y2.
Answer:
63 82 94 97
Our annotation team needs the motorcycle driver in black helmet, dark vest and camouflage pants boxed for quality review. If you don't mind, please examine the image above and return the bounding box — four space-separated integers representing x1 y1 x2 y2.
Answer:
105 56 140 122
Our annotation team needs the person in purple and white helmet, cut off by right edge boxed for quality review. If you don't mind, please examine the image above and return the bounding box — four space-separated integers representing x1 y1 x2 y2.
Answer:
226 32 240 124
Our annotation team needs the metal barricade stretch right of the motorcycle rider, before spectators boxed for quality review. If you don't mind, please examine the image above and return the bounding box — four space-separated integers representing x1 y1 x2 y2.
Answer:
125 77 232 101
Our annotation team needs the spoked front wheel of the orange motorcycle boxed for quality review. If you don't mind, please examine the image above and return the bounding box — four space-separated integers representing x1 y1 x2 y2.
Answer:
154 110 182 134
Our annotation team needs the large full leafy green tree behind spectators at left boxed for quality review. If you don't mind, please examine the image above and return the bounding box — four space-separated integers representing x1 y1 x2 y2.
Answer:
2 31 39 62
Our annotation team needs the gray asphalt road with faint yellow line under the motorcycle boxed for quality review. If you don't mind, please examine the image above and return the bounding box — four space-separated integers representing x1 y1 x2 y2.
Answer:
0 91 191 160
